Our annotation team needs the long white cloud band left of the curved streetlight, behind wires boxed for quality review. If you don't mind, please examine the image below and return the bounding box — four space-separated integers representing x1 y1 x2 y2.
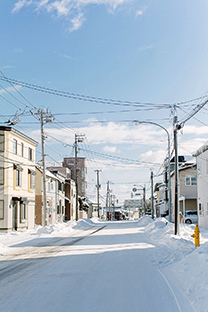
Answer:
33 119 172 149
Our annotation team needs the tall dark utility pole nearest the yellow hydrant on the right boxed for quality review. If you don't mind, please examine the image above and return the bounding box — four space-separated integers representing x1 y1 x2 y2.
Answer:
174 116 180 235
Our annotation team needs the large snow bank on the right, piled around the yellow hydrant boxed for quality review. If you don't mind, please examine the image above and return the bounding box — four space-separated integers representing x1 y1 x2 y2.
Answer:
139 218 208 312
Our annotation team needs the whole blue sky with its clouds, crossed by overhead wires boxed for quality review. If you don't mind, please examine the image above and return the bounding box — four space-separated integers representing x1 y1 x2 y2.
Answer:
0 0 208 202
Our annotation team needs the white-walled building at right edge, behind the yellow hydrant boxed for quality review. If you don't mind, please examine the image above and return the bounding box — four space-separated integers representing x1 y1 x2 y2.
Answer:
193 142 208 229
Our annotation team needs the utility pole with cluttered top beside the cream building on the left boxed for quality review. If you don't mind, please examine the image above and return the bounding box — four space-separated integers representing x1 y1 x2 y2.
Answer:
33 108 53 225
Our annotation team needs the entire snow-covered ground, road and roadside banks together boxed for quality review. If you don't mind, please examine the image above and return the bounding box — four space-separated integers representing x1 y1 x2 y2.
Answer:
0 216 208 312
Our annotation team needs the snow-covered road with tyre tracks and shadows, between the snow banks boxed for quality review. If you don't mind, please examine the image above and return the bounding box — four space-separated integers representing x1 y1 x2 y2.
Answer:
0 221 193 312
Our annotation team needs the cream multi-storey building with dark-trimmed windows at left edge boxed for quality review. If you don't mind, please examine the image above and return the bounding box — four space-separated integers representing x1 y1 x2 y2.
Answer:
0 126 38 232
